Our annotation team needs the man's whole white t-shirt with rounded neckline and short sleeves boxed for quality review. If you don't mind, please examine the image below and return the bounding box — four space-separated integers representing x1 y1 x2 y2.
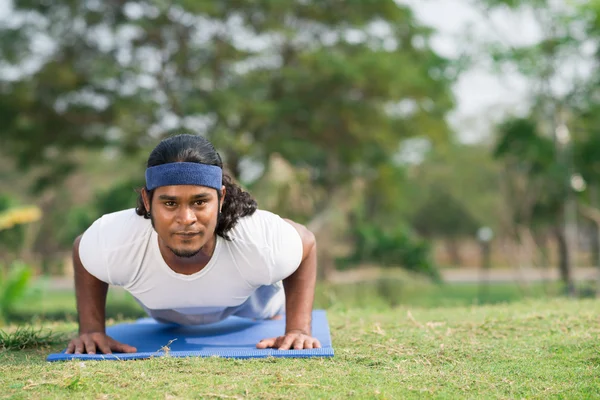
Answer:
79 209 302 320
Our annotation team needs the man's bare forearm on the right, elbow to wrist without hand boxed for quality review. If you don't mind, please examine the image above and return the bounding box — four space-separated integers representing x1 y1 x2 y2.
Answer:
283 242 317 335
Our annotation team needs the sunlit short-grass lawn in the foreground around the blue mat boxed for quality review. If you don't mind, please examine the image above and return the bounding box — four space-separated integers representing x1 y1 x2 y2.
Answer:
0 299 600 399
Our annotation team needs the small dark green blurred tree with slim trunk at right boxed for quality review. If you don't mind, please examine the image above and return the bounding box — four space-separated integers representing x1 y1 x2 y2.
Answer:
495 118 575 294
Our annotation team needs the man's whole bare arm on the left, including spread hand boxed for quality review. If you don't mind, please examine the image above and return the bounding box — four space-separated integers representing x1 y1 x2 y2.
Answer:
66 236 136 354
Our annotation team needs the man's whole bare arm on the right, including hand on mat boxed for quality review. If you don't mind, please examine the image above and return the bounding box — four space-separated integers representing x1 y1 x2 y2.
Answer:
256 219 321 350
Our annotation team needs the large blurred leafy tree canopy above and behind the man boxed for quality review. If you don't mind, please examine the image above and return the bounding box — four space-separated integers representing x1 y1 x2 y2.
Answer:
0 0 459 276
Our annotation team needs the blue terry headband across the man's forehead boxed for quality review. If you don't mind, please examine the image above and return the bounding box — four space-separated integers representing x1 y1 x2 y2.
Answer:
146 162 223 190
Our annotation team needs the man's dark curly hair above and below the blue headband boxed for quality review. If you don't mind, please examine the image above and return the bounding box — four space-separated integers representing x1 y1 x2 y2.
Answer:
135 134 257 240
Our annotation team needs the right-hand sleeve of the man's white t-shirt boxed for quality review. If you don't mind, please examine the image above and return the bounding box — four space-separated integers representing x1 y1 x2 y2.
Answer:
263 212 303 284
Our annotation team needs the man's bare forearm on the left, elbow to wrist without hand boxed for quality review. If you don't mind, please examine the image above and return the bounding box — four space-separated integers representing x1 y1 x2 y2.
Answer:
73 239 108 334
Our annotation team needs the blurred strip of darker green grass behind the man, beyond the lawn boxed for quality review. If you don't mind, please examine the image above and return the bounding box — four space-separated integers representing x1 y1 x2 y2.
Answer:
8 278 572 323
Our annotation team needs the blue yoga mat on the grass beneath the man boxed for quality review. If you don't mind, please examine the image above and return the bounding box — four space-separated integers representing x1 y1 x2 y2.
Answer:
47 310 333 361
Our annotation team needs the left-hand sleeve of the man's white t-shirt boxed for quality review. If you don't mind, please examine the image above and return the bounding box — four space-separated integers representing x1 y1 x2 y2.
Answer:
79 218 112 284
